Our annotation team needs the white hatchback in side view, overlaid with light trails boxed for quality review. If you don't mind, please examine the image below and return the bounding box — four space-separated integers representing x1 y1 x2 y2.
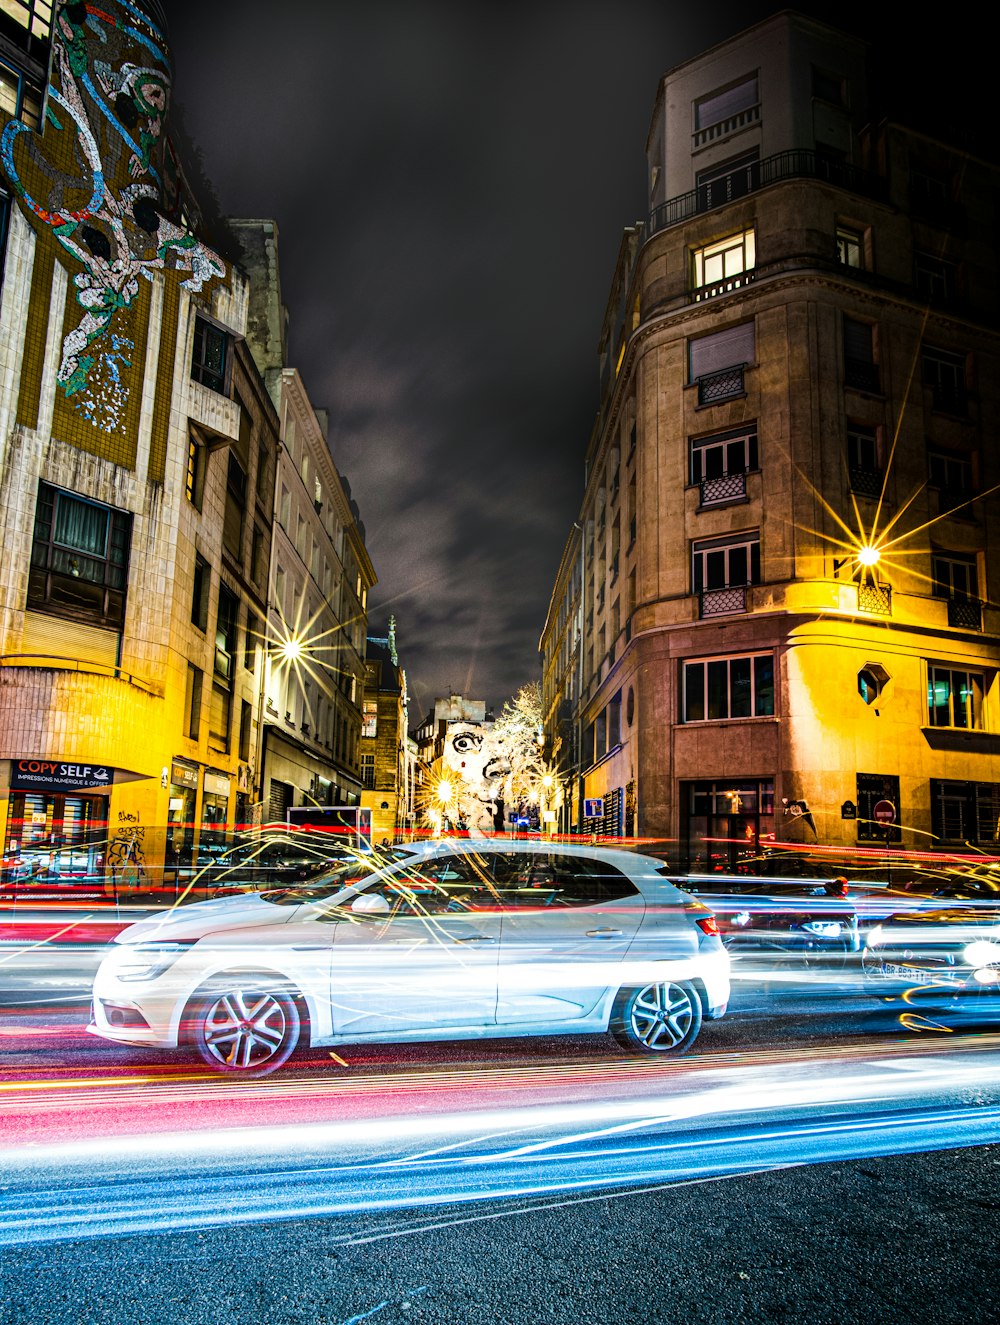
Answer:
89 839 730 1076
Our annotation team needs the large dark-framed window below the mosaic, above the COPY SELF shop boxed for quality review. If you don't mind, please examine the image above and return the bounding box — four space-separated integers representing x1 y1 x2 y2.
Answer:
26 482 132 629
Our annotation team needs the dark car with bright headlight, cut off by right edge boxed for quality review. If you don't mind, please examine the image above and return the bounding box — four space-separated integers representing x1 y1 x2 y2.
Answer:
861 878 1000 1011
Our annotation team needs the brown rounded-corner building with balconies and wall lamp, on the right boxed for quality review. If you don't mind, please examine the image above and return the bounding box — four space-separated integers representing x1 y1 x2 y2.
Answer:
542 13 1000 869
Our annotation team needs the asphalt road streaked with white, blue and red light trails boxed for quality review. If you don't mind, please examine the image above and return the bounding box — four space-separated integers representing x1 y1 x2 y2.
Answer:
0 953 1000 1325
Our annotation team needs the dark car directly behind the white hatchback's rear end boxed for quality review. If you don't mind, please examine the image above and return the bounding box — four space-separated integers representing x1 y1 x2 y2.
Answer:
674 875 861 966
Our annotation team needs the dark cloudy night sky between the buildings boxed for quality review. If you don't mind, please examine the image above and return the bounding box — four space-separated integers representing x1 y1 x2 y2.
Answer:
167 0 980 725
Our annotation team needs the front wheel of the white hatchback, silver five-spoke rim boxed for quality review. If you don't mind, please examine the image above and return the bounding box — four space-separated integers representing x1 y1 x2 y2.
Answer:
187 975 302 1077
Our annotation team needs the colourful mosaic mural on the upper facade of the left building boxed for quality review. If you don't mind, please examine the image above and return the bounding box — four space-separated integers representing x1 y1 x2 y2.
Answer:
0 0 228 433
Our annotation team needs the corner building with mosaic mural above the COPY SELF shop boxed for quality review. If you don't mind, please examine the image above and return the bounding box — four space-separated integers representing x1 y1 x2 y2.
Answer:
0 0 278 890
